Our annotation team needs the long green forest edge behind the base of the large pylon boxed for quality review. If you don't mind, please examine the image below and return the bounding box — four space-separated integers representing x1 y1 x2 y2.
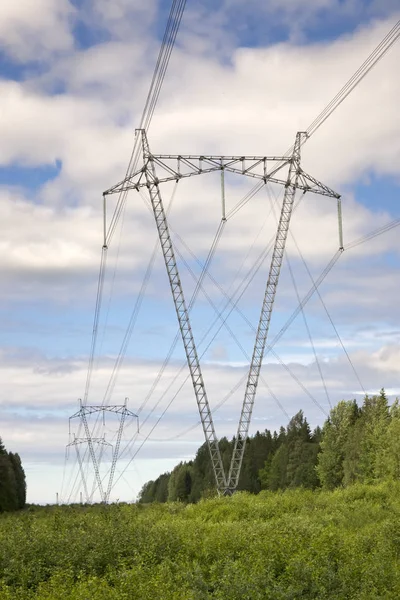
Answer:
139 389 400 503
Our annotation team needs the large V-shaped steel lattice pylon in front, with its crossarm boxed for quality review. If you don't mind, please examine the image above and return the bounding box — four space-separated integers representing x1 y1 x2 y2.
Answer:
103 129 340 494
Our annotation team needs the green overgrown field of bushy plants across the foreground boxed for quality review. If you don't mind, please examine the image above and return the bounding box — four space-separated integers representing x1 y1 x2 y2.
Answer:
0 483 400 600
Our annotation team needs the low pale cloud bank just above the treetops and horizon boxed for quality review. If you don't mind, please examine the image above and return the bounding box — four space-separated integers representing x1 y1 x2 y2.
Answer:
0 345 400 502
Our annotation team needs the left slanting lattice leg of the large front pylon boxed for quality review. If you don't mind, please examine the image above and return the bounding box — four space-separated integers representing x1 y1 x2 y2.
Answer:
141 130 226 489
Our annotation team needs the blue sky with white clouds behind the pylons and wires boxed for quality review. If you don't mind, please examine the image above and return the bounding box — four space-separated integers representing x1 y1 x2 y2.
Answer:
0 0 400 502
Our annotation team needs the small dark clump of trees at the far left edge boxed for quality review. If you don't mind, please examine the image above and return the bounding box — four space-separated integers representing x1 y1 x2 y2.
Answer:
0 438 26 513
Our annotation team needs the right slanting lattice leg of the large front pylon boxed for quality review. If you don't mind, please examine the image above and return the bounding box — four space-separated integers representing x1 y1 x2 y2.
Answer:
227 132 306 493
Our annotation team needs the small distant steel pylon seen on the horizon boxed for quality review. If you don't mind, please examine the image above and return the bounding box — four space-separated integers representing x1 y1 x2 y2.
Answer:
67 399 139 503
